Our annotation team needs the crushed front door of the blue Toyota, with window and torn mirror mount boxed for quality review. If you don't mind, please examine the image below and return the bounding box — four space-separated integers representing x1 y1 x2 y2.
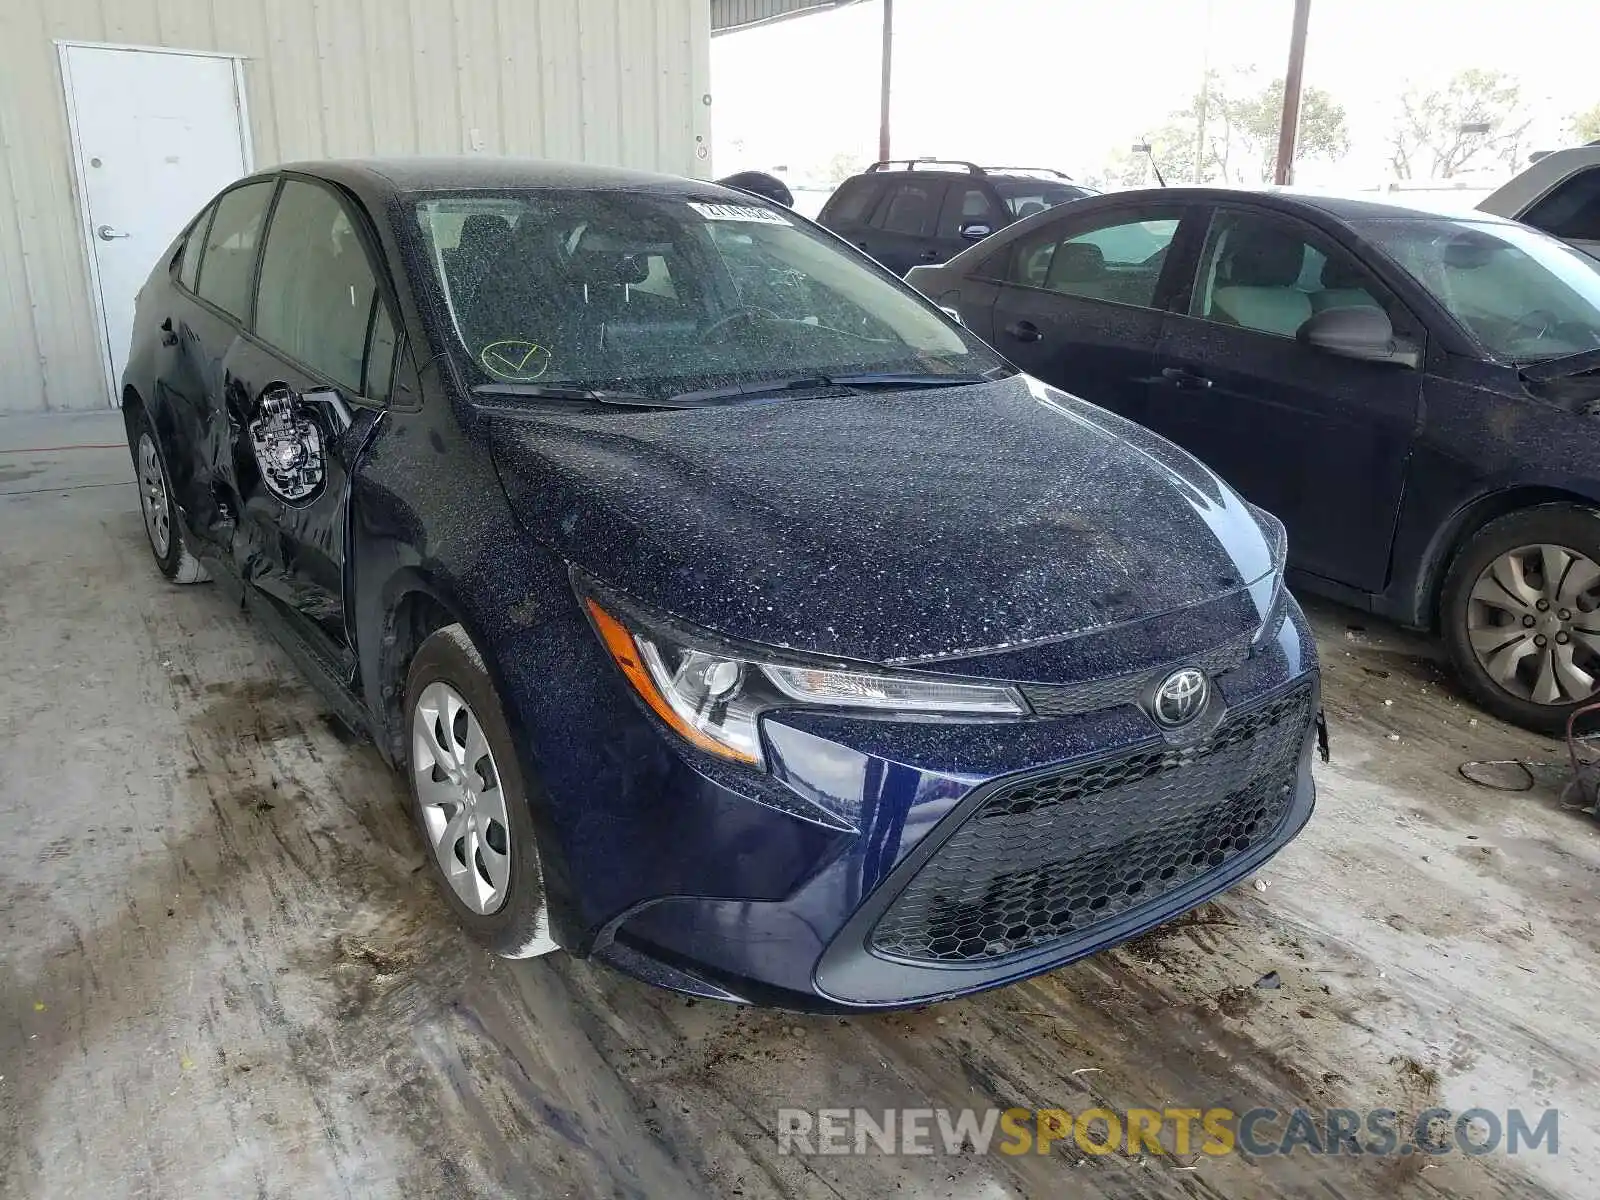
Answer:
227 176 397 675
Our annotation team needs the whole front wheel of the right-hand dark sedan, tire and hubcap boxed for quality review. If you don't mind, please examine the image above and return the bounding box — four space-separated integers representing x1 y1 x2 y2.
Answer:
1438 504 1600 733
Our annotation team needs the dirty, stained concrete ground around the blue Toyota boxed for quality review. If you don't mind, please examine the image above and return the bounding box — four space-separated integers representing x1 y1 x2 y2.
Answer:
0 414 1600 1200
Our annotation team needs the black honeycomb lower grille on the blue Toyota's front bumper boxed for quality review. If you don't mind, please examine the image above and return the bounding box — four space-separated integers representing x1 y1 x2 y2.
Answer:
872 688 1310 963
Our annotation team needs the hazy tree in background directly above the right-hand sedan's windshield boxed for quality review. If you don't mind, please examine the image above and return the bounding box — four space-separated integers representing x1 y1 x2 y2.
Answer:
1389 67 1530 179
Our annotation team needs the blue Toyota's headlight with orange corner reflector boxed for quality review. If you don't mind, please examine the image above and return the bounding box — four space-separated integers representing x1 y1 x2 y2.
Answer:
584 595 1029 766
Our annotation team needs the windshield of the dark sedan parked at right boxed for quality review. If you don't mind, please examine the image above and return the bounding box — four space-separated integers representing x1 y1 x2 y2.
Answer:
1360 218 1600 363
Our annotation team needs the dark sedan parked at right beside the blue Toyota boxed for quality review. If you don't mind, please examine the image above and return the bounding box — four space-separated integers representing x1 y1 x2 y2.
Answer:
909 187 1600 730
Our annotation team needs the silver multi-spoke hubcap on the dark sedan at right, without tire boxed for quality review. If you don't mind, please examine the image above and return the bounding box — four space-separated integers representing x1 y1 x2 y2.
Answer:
1467 546 1600 704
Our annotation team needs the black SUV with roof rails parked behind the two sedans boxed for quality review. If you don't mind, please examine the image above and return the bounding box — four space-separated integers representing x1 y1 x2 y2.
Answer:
818 158 1098 275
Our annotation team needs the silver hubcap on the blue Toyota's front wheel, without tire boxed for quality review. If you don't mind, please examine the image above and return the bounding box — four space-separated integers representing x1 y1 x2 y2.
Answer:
411 682 510 914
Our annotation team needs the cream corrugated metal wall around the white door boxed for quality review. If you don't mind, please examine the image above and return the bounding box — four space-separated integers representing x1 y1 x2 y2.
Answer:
0 0 710 413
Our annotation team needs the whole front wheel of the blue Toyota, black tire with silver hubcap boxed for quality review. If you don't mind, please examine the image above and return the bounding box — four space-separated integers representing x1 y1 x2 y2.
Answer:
405 624 560 958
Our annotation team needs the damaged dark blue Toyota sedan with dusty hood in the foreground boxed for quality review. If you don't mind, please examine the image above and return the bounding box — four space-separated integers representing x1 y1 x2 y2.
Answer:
123 160 1318 1008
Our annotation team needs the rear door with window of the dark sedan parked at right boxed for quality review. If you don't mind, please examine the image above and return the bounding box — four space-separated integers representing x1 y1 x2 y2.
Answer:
992 205 1184 421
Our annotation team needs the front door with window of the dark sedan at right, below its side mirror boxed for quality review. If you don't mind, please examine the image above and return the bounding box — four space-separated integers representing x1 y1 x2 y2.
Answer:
1144 206 1426 592
